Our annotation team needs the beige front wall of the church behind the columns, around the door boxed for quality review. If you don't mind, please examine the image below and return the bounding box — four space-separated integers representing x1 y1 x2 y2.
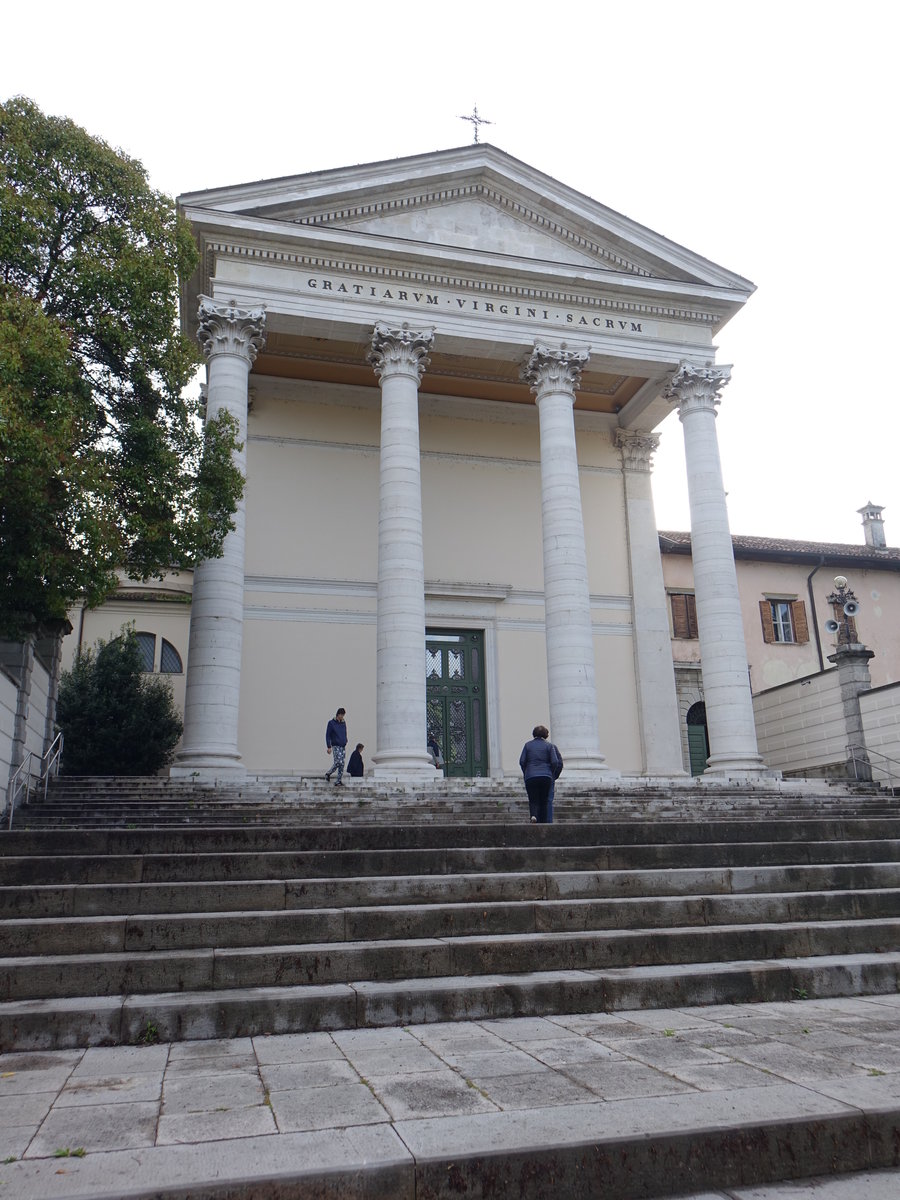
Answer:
240 379 641 774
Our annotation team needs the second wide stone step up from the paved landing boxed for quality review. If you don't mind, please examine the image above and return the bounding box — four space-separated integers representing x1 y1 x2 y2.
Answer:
7 918 900 1001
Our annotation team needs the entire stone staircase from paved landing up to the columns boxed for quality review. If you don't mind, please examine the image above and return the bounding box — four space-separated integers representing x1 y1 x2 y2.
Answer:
0 781 900 1051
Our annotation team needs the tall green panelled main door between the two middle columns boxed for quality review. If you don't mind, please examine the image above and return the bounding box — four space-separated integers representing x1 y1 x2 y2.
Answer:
425 629 487 779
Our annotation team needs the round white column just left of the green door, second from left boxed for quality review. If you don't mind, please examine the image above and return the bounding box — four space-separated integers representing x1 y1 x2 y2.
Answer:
368 322 438 782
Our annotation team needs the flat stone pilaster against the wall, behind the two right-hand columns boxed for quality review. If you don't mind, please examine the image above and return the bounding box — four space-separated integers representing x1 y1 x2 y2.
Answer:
616 430 685 775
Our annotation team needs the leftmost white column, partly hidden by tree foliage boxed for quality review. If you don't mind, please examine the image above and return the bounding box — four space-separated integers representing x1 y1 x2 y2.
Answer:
170 296 265 779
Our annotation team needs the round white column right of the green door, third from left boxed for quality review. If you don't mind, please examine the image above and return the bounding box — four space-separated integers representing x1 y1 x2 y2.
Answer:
522 344 611 782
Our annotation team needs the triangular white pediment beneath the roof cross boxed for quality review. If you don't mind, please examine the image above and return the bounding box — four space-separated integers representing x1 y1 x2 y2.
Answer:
180 145 752 294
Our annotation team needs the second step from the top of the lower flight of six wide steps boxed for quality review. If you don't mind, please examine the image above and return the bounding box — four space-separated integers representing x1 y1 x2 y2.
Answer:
7 839 900 887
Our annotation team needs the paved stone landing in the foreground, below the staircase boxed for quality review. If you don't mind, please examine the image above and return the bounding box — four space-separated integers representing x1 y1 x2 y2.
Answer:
0 995 900 1200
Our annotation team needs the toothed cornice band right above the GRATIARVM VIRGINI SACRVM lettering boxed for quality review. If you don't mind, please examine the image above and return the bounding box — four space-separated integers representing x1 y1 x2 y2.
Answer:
204 239 724 329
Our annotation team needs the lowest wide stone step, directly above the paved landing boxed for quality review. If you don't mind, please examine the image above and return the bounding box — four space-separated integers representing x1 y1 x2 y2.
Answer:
0 953 900 1051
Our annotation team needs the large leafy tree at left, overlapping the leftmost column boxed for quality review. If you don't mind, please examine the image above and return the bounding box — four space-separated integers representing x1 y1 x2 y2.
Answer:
0 97 242 637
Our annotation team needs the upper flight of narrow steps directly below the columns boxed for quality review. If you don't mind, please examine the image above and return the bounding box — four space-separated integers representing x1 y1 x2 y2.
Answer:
13 775 900 830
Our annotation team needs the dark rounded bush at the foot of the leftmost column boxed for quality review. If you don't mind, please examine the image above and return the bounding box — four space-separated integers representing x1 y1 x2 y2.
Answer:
56 626 182 775
